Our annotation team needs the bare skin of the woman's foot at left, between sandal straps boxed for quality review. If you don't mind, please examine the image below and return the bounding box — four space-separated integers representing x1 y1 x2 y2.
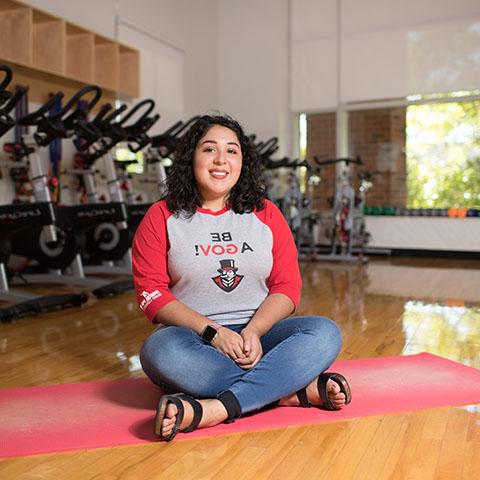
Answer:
160 399 227 439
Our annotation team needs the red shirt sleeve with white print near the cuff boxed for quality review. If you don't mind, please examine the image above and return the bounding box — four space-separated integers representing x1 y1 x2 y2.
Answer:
132 202 175 322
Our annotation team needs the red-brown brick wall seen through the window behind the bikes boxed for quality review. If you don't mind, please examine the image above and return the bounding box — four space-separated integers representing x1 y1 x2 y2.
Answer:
307 107 407 210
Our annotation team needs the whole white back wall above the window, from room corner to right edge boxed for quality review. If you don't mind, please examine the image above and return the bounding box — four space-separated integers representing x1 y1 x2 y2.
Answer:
218 0 480 155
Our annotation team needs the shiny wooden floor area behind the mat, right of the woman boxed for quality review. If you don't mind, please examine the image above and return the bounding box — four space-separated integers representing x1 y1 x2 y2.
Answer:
301 259 480 367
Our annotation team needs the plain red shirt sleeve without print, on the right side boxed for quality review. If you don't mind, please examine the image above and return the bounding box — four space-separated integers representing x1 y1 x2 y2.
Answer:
259 200 302 308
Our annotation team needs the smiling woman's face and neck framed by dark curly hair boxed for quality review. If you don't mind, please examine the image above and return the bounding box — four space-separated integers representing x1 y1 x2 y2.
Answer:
193 125 242 210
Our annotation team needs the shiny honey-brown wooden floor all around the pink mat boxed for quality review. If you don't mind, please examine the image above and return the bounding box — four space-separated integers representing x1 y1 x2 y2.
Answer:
0 259 480 480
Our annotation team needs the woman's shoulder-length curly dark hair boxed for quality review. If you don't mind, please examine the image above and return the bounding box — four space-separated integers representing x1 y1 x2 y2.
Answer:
164 115 266 217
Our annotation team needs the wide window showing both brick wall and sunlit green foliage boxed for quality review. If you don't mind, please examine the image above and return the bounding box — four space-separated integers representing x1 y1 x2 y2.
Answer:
300 91 480 209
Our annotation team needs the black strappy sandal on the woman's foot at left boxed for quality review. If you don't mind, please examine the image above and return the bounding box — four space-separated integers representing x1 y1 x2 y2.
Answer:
154 393 203 442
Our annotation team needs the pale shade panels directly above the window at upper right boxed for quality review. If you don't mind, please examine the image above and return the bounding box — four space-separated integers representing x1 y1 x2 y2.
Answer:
291 0 480 111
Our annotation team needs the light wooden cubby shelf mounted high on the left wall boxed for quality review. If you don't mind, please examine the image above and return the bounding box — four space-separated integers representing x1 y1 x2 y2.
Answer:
0 0 140 100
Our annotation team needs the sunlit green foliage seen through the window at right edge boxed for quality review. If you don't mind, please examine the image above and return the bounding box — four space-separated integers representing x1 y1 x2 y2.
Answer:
406 92 480 208
